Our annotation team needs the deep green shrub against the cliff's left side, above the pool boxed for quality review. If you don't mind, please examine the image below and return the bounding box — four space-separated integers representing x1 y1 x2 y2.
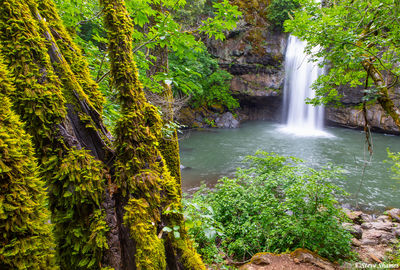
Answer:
169 49 239 109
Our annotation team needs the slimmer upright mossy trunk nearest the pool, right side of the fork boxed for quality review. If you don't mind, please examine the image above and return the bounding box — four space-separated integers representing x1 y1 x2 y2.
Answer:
100 0 205 269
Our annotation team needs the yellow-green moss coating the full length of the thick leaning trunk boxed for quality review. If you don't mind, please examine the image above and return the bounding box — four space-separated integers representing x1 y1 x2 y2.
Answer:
0 0 108 269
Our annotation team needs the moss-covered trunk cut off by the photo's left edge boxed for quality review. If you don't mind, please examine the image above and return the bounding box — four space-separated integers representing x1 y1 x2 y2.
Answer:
0 56 56 270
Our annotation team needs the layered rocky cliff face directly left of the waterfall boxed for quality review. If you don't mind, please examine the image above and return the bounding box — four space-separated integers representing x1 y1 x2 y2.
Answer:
207 21 287 120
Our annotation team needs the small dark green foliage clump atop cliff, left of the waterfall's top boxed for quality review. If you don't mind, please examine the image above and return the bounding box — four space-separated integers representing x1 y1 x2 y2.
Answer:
267 0 300 31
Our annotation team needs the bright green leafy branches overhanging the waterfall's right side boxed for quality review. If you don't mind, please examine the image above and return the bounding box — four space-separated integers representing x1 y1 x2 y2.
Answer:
285 0 400 107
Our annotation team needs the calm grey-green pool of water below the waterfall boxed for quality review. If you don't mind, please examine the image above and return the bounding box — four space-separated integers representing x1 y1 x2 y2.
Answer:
180 121 400 211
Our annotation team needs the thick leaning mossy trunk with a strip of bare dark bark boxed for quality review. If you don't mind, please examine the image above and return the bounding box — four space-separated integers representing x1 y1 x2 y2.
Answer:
0 0 116 269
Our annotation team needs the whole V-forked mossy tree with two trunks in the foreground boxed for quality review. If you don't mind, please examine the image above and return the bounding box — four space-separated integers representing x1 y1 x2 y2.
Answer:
0 0 204 270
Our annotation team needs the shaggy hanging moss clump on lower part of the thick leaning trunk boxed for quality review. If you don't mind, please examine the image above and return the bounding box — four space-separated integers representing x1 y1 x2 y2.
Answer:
44 149 108 269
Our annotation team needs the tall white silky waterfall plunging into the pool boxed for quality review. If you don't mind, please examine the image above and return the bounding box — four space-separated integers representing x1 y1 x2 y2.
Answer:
284 36 326 136
